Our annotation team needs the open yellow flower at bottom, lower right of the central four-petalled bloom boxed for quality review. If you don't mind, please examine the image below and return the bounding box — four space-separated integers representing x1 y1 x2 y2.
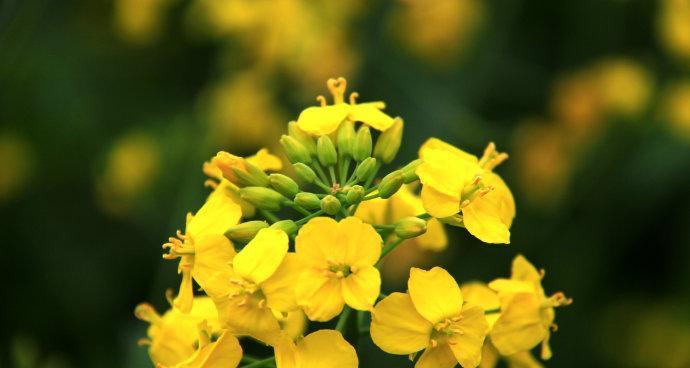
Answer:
371 267 489 368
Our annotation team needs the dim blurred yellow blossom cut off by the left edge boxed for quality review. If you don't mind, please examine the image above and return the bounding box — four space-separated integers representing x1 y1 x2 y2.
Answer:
0 133 33 202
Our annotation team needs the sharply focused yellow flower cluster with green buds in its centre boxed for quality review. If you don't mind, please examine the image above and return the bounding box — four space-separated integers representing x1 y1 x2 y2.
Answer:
136 78 571 368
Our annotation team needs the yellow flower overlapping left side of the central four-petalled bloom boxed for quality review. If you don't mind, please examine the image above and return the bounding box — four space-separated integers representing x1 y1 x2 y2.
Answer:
199 228 301 343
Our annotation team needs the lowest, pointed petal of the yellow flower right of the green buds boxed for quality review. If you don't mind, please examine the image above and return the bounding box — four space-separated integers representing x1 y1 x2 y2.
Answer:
462 194 510 244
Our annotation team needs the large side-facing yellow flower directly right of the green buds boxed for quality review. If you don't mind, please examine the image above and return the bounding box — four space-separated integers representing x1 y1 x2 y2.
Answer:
417 138 515 244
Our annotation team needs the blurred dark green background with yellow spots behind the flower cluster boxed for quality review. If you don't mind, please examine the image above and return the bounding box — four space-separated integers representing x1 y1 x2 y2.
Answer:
0 0 690 368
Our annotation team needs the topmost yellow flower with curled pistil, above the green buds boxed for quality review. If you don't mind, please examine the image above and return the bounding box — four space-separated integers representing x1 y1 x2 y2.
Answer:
297 77 394 136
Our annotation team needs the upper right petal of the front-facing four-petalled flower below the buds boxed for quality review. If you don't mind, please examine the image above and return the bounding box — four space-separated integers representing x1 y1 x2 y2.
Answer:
332 217 382 267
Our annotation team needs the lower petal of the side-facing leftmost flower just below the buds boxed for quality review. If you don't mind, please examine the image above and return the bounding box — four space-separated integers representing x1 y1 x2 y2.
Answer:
192 234 236 296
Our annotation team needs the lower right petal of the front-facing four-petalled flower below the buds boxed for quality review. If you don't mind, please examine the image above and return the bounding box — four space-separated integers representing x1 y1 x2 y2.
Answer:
343 266 381 311
